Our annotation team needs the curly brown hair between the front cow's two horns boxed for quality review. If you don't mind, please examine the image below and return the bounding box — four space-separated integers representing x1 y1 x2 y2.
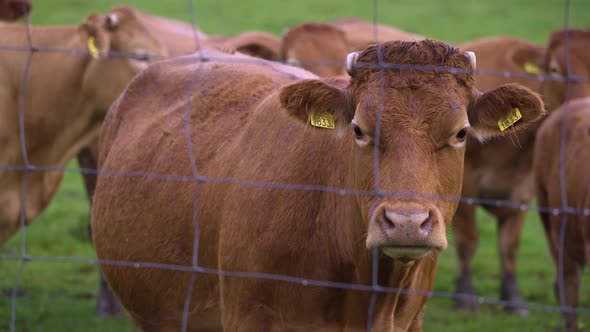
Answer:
350 39 474 86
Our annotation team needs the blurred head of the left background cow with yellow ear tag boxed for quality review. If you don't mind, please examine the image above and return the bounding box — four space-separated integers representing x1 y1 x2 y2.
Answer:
79 6 167 110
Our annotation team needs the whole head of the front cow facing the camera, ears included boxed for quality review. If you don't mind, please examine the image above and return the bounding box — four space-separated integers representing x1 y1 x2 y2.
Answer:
280 40 545 259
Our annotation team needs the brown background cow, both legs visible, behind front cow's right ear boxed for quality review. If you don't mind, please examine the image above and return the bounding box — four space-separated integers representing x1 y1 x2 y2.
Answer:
453 37 550 315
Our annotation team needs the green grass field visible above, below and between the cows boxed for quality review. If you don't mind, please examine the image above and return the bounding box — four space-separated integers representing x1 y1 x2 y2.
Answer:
0 0 590 332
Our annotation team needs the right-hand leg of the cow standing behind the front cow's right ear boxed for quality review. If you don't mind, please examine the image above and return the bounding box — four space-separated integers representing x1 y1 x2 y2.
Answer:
498 209 528 316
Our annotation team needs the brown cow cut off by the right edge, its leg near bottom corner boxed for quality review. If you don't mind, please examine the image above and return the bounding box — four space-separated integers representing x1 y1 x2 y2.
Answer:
534 97 590 331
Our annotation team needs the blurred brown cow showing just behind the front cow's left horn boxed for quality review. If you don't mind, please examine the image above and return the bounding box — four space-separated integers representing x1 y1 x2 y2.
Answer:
280 19 424 77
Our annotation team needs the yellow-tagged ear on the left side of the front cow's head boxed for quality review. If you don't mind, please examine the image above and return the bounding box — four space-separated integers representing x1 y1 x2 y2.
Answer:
279 79 354 131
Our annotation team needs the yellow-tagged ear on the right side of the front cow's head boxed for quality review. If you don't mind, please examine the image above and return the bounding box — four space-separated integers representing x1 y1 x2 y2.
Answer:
467 83 547 141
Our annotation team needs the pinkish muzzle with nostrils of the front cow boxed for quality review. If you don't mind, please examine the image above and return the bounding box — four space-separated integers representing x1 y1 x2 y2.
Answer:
366 204 447 260
